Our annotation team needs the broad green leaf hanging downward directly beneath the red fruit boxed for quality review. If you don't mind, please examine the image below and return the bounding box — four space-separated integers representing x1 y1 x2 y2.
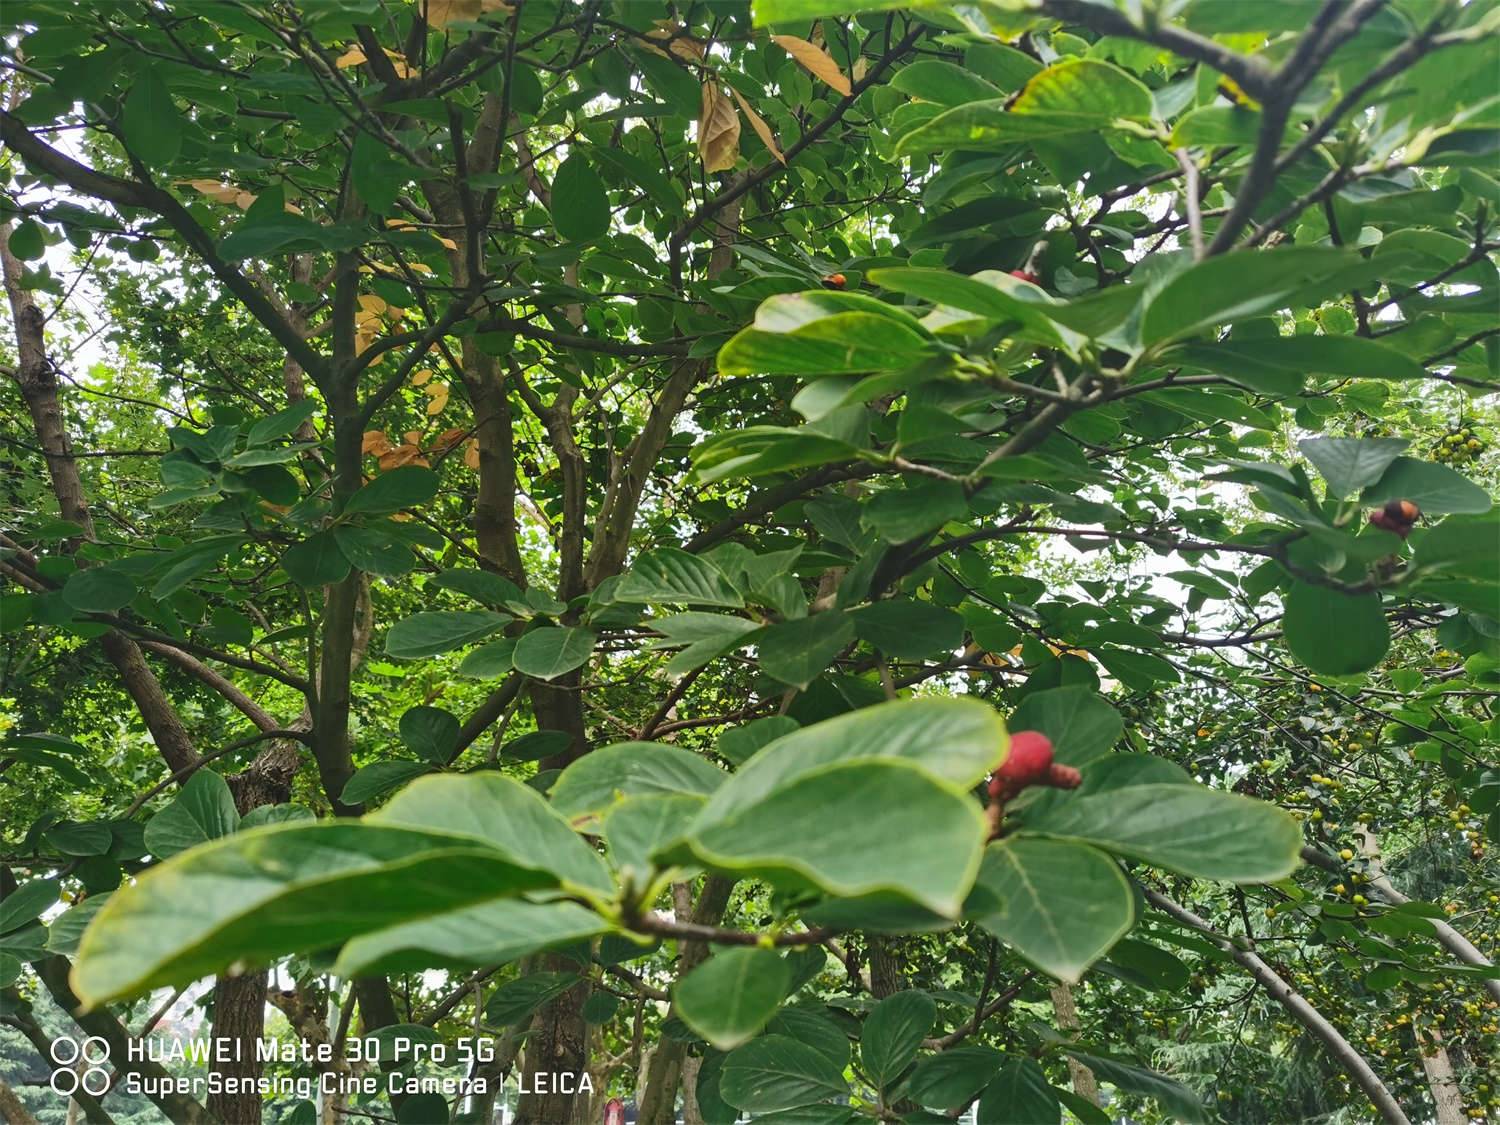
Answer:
965 837 1136 984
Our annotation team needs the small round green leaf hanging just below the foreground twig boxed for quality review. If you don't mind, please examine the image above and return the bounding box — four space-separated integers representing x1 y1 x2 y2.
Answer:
672 947 792 1052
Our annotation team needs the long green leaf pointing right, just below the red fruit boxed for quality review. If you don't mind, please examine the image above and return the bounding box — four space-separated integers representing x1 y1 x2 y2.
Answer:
1022 783 1302 884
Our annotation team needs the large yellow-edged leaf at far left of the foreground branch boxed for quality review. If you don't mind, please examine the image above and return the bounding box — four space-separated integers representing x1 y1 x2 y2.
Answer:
72 822 558 1005
